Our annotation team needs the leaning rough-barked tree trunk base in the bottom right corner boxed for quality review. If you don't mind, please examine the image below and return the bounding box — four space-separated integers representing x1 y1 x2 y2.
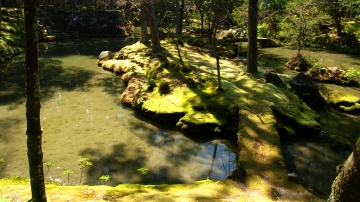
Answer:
328 137 360 202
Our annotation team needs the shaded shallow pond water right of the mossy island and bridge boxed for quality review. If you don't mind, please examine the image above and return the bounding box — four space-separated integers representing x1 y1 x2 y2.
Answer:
260 48 360 194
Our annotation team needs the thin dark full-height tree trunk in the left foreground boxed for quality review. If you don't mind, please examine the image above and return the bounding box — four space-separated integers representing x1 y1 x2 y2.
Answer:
24 0 46 202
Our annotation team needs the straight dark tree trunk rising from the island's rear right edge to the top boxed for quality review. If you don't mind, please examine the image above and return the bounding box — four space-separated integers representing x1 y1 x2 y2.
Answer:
247 0 258 73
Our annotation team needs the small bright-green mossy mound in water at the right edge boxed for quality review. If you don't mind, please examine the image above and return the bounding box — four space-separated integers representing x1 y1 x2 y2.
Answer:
327 91 360 114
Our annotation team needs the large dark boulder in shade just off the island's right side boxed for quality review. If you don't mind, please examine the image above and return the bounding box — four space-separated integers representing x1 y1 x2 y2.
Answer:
290 72 326 106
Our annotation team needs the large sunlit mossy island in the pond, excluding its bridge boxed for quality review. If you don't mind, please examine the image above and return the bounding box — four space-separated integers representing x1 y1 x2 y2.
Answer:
102 38 320 139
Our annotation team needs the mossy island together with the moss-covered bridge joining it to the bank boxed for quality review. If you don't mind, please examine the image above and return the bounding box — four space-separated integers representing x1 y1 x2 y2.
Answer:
95 36 322 201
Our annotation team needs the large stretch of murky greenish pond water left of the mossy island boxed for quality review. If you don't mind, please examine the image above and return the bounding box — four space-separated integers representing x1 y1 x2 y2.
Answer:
0 38 236 185
